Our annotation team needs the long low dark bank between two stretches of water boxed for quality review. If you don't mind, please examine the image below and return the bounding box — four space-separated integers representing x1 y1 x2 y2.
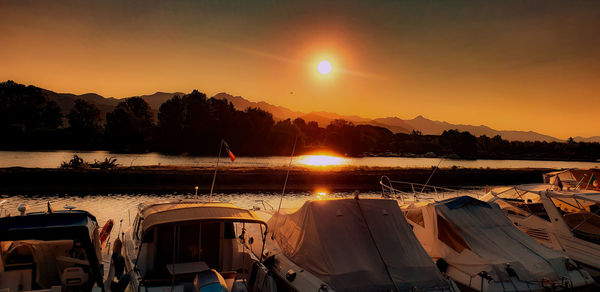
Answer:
0 166 553 196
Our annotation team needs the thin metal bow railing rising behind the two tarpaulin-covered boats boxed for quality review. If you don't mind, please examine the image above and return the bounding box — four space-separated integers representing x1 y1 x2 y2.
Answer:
379 175 484 203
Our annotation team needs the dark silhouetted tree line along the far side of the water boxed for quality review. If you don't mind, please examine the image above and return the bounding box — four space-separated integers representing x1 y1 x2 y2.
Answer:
0 81 600 161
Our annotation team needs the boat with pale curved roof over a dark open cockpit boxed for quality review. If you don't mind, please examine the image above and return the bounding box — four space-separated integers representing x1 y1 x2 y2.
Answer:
118 200 276 292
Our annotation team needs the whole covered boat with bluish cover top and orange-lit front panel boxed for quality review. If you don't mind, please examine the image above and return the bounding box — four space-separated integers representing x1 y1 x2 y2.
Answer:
403 196 594 291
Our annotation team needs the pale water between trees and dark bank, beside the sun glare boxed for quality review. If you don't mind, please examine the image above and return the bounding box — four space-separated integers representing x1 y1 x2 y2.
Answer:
0 151 600 168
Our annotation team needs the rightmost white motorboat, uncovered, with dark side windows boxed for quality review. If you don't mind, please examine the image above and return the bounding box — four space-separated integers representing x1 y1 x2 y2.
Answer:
482 184 600 279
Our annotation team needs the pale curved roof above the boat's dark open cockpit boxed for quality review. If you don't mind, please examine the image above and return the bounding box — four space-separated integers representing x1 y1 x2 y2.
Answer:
140 201 267 232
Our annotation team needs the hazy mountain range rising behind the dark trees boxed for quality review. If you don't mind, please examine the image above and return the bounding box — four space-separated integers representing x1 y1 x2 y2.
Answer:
42 85 600 142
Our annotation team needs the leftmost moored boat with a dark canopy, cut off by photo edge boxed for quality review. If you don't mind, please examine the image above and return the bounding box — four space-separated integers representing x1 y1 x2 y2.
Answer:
0 208 104 291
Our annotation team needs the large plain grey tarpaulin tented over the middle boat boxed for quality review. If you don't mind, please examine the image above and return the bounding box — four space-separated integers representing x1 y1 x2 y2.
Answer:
268 199 450 291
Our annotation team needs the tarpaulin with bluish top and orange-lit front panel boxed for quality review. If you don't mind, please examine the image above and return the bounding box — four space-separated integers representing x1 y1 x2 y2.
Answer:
415 197 567 281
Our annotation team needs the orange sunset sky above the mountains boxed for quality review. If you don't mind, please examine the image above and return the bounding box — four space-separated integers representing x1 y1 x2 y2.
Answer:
0 0 600 138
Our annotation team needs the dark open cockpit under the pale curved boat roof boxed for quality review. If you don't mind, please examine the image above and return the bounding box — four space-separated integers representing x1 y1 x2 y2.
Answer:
137 221 265 286
